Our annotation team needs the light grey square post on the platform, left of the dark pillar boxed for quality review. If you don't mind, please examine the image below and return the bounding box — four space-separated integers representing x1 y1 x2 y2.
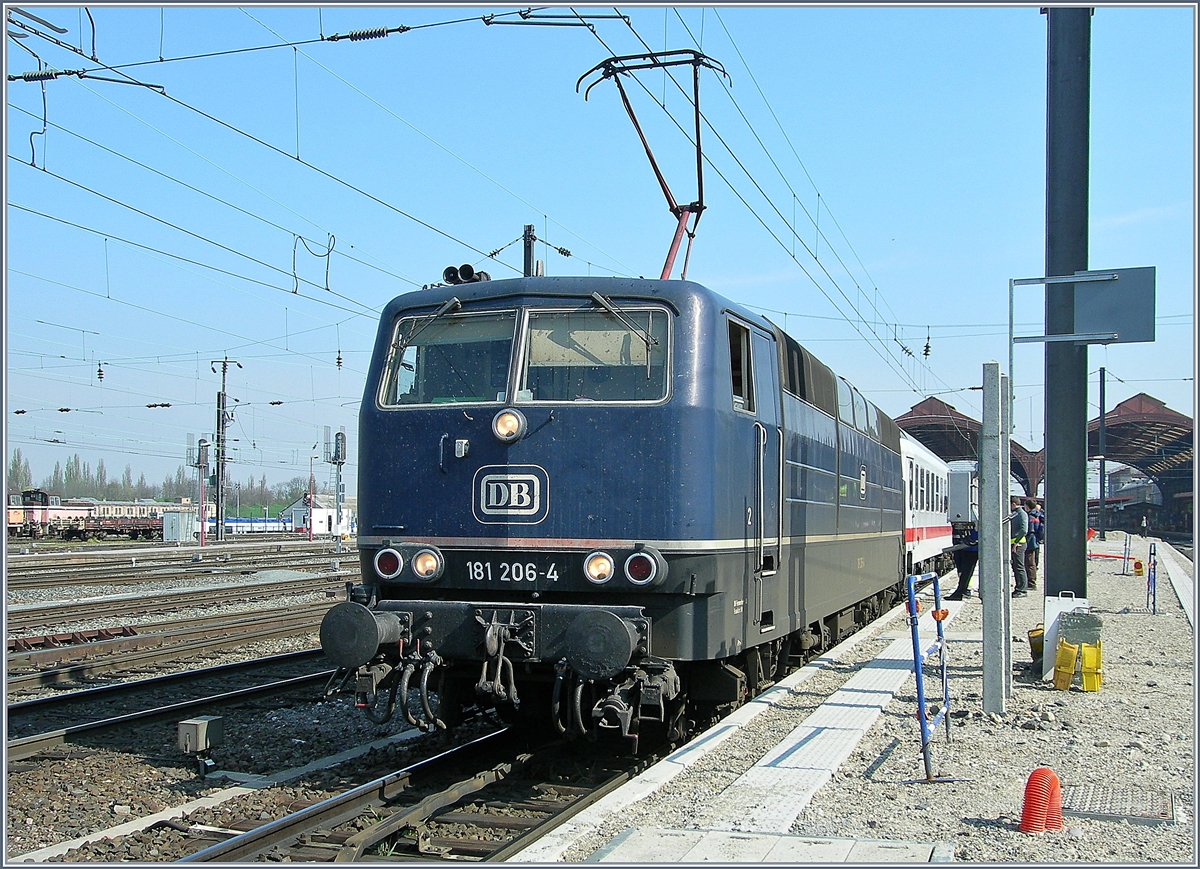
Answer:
979 362 1012 715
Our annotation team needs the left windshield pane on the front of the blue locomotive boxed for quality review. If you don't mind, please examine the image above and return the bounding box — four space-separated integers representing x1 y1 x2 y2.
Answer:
379 311 516 407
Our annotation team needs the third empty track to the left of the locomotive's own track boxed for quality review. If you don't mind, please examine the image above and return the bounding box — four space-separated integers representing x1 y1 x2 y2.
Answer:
5 569 348 633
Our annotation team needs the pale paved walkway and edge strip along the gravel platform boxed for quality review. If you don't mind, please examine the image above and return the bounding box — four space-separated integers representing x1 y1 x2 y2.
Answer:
512 580 962 863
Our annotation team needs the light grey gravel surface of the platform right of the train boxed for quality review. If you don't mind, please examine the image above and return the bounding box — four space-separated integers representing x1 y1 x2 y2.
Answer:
562 534 1196 865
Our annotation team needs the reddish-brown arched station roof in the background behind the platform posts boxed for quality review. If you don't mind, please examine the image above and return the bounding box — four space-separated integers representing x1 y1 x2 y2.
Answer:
896 392 1195 498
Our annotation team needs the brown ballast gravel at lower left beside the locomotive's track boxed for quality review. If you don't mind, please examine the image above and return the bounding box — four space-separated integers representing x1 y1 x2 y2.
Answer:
6 662 497 861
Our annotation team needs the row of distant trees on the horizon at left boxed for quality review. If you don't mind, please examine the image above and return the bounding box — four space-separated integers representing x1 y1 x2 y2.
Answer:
7 448 314 516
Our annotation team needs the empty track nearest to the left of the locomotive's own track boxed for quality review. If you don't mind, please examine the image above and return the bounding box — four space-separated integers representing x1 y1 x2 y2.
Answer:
6 649 335 771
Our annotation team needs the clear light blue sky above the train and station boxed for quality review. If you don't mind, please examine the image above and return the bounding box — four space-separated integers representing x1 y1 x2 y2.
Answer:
5 5 1196 493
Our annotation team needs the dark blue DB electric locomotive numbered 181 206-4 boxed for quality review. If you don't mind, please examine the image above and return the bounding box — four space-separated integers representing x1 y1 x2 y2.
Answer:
320 277 904 741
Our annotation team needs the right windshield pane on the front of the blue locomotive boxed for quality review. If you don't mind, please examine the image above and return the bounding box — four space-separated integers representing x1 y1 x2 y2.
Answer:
517 308 668 401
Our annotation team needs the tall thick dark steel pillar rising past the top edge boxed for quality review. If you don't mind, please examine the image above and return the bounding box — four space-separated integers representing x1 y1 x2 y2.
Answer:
1042 7 1092 600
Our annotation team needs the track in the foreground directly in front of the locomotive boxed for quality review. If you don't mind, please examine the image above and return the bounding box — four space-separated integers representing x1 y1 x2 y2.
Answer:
179 730 652 863
